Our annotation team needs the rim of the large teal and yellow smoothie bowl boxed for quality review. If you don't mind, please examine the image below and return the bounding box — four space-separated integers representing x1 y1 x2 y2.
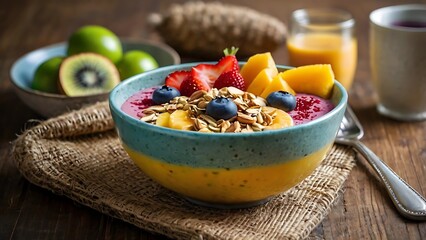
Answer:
108 62 348 138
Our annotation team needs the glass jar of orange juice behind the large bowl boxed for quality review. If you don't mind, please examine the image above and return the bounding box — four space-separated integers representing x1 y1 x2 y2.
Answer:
287 8 357 90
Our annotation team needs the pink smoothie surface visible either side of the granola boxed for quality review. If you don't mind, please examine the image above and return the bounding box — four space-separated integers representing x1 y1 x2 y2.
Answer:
121 87 334 125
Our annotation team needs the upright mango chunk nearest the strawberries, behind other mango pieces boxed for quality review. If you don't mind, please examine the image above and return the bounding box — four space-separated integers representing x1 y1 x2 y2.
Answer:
240 52 278 86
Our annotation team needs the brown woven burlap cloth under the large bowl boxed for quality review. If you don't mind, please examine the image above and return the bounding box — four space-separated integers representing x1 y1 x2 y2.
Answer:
12 102 355 239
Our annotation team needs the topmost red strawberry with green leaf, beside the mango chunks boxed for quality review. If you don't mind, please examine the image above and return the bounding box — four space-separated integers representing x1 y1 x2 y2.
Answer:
191 48 240 88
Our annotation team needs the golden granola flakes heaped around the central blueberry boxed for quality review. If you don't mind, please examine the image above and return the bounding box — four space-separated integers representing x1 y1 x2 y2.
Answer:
141 87 277 133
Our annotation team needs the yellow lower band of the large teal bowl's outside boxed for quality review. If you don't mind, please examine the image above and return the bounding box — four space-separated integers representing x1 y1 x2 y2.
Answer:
124 143 332 204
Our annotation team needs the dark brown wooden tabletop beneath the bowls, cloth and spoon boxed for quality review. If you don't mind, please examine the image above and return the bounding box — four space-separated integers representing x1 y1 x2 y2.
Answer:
0 0 426 239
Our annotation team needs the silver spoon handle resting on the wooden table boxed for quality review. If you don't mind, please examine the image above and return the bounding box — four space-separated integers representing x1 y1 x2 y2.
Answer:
353 141 426 220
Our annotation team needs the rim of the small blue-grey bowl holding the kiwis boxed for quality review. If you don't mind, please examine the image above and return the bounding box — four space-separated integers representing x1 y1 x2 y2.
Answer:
9 38 181 100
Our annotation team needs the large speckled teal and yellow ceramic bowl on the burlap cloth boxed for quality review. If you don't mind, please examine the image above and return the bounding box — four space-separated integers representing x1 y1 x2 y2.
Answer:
109 63 347 208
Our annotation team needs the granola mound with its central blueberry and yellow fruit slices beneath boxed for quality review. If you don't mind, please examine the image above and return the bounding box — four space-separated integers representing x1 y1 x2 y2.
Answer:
140 87 293 133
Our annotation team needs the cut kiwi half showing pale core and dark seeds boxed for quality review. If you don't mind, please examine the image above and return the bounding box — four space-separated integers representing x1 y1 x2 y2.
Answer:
59 53 120 96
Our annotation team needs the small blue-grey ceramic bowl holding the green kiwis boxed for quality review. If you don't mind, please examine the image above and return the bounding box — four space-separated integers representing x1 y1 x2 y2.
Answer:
10 40 181 117
